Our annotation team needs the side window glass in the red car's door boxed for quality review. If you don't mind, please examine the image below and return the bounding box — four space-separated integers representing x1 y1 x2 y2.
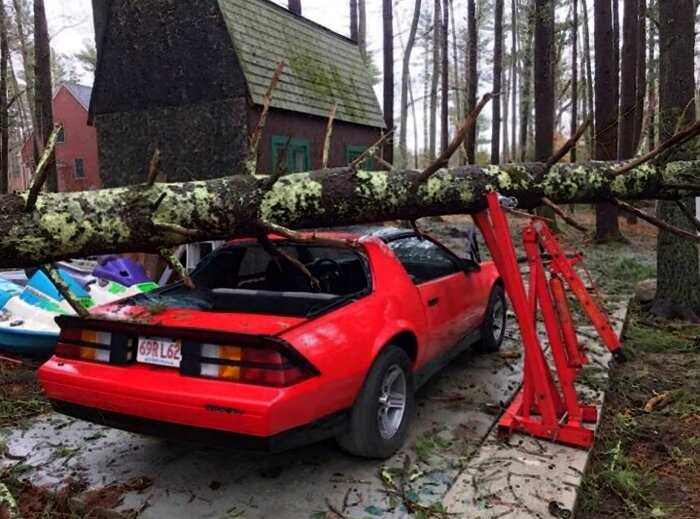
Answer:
389 236 459 285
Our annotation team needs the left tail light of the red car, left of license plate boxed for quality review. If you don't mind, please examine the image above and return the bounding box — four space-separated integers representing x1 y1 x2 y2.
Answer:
55 328 133 364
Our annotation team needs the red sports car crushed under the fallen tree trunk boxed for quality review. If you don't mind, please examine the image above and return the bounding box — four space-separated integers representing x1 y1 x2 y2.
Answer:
39 228 506 458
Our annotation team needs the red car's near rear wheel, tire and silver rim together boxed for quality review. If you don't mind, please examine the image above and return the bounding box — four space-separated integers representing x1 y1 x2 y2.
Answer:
338 346 415 459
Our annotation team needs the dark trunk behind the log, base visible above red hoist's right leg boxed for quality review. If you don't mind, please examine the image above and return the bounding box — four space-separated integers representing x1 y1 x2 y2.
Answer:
594 1 622 242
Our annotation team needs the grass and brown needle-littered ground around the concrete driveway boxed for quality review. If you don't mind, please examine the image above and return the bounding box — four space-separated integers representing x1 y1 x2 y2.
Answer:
0 209 700 519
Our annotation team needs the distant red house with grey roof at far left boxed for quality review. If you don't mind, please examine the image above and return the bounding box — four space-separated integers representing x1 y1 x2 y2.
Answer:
15 83 101 192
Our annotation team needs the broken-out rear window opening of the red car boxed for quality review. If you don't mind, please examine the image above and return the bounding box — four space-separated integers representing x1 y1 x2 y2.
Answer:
130 241 369 316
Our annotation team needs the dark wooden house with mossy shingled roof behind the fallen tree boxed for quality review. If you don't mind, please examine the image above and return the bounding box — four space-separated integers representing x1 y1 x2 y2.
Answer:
90 0 384 187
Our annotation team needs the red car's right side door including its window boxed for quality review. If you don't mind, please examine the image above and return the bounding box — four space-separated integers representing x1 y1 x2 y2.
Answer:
389 235 468 358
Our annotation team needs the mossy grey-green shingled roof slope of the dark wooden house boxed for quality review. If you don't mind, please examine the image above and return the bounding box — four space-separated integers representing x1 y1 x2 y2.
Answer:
218 0 385 128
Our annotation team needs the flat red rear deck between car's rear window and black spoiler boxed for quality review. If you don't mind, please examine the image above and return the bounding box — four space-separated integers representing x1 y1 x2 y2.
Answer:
91 304 308 336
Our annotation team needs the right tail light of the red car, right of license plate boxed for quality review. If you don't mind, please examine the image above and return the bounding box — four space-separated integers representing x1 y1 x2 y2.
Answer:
180 342 317 387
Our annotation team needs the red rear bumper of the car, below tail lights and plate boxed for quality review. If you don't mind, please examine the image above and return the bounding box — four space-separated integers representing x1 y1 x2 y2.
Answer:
39 357 343 450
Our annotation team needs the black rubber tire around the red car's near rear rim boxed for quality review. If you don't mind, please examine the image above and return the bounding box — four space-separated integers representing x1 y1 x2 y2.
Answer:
337 346 416 459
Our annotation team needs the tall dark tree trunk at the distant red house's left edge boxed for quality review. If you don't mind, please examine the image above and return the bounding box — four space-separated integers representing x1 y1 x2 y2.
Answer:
34 0 58 191
